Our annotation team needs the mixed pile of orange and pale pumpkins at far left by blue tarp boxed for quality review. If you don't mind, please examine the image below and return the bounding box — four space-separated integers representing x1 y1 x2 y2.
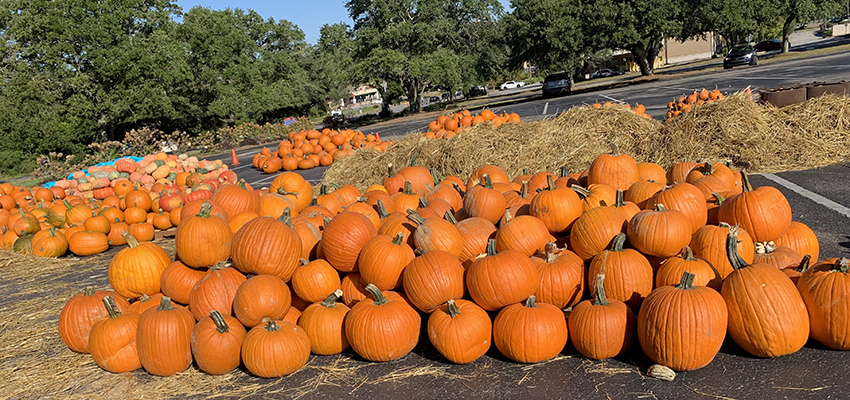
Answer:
0 158 238 257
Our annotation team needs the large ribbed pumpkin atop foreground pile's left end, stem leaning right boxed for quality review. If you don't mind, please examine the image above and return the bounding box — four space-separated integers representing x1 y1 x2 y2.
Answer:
229 209 302 282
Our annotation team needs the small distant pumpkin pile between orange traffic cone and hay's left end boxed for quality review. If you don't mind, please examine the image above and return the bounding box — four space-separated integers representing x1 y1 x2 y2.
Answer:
252 128 392 174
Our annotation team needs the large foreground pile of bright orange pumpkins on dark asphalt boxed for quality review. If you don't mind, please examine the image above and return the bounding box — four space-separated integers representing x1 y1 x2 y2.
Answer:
59 147 850 377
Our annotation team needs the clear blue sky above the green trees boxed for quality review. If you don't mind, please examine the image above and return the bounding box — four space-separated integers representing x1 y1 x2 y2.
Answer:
169 0 510 44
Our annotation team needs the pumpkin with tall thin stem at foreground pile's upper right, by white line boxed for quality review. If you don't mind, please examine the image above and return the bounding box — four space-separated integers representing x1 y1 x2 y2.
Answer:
717 173 791 242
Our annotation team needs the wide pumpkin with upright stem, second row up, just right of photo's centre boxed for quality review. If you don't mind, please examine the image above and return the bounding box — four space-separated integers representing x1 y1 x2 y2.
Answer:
466 239 540 311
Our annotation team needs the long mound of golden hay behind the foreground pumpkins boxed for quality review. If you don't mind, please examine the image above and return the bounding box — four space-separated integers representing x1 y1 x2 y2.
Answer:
324 92 850 190
